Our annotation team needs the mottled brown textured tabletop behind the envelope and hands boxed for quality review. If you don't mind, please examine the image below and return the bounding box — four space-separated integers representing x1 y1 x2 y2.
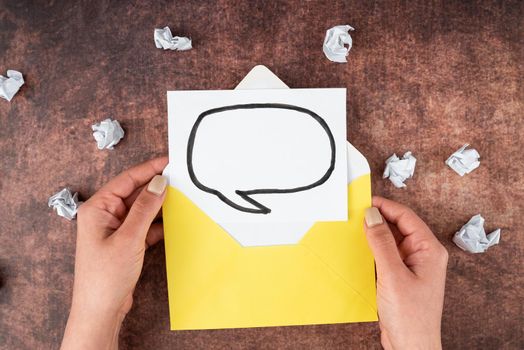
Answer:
0 0 524 349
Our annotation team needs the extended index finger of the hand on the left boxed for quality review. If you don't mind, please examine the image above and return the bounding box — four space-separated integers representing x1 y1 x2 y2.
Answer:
100 157 168 198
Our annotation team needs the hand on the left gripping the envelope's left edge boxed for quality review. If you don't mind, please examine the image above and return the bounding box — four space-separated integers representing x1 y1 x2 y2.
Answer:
62 158 167 349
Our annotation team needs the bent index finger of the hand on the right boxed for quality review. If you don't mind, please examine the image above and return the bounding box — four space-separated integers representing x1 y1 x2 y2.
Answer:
373 197 436 239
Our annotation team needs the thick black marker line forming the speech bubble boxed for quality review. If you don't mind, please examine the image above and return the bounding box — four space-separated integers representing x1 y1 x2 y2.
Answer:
187 103 336 214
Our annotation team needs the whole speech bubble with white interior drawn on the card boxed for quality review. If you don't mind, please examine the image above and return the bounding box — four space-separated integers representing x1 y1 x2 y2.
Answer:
187 103 336 214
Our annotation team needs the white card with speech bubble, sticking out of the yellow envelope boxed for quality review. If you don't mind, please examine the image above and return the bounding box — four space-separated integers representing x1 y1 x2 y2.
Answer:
168 89 347 223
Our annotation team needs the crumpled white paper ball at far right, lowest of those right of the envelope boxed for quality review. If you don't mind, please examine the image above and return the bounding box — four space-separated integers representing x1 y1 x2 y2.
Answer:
453 214 500 253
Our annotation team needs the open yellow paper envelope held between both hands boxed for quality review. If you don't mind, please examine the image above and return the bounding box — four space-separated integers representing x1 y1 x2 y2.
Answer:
163 67 377 330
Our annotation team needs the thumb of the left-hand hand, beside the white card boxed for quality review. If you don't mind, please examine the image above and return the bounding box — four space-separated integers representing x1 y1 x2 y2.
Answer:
119 175 167 242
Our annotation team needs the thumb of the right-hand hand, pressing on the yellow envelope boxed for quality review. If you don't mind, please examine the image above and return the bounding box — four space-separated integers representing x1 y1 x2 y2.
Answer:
364 207 406 276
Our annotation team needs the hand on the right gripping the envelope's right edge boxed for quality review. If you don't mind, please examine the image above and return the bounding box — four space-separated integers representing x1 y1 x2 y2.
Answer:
364 197 448 349
